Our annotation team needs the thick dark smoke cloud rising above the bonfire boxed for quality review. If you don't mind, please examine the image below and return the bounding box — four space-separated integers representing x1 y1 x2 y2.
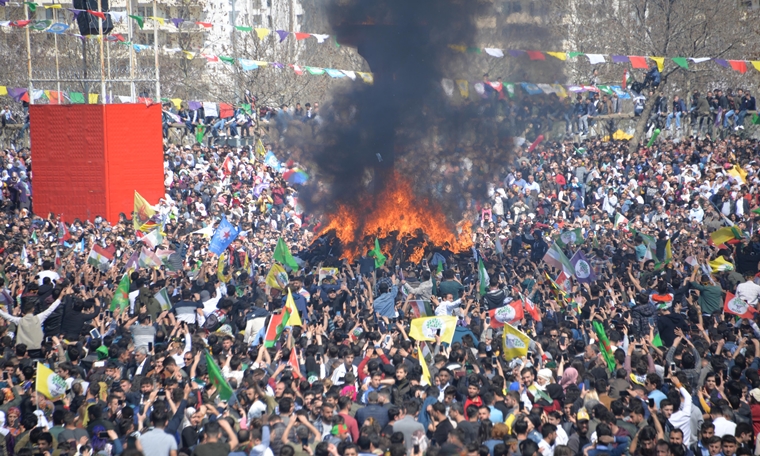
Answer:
302 0 511 222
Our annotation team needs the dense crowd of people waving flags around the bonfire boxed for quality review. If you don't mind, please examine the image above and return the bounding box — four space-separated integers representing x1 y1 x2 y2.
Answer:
0 84 760 456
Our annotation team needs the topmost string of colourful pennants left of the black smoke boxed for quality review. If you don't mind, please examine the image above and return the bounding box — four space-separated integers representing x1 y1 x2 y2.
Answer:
0 0 340 47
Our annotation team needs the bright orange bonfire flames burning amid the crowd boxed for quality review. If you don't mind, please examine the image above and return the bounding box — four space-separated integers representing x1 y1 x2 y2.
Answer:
320 174 472 263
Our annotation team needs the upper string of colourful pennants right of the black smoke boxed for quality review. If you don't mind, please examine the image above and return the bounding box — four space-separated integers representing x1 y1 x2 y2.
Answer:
449 44 760 74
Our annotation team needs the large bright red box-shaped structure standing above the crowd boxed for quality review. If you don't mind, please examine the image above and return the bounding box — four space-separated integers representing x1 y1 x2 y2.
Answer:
29 104 164 223
